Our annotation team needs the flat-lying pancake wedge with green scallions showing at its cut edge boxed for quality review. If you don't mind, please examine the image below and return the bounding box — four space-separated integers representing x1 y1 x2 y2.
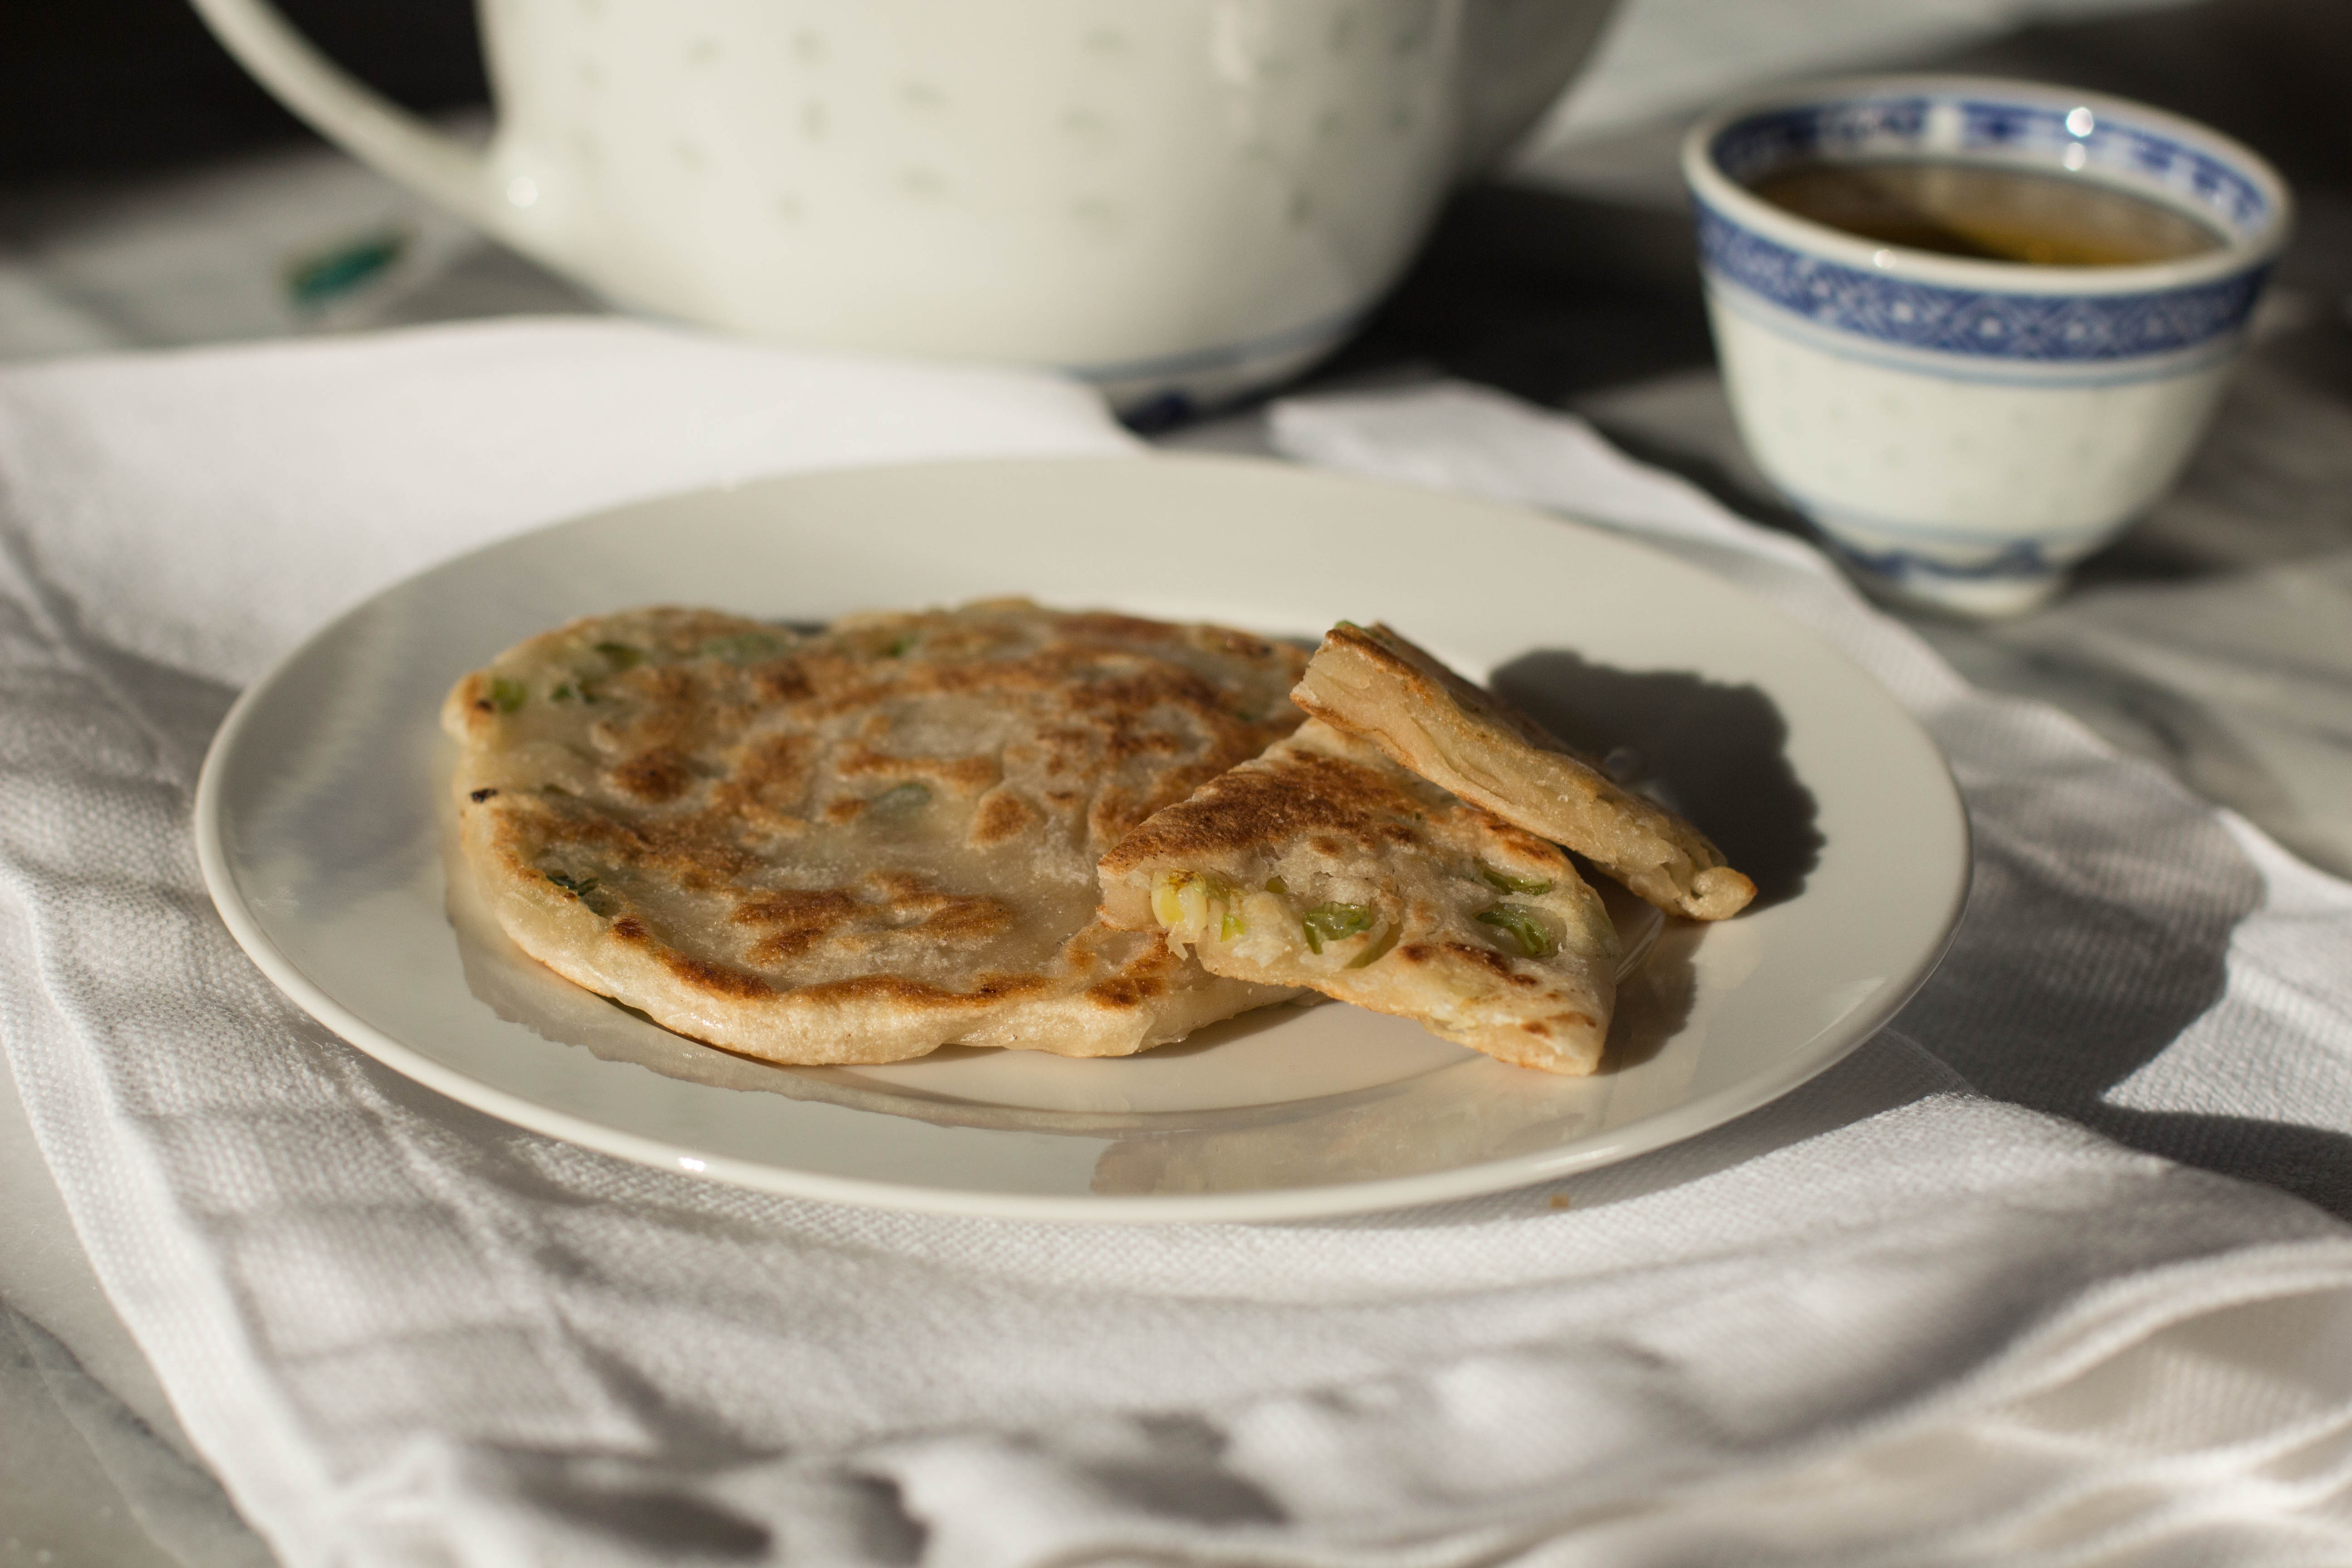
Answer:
1101 720 1618 1074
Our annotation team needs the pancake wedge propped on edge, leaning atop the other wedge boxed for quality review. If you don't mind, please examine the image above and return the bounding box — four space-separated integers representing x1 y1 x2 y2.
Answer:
1291 621 1757 919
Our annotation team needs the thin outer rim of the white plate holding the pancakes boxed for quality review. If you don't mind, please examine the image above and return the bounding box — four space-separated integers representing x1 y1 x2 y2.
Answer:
193 451 1976 1225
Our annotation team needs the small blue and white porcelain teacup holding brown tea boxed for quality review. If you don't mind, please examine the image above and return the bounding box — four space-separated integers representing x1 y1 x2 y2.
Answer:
1682 75 2291 616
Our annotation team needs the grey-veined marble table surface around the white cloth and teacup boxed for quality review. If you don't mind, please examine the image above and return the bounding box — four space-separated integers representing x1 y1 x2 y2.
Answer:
0 0 2352 1568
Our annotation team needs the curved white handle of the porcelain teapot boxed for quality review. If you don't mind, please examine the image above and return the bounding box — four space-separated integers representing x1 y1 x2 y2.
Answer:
193 0 560 261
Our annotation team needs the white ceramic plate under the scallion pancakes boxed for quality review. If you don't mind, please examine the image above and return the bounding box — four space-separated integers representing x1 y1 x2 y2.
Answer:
197 458 1969 1220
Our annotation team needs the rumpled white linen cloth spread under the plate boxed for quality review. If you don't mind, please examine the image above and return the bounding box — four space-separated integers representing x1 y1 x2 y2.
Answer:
0 322 2352 1566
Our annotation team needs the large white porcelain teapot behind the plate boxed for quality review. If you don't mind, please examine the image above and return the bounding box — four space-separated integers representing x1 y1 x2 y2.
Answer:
195 0 1609 407
